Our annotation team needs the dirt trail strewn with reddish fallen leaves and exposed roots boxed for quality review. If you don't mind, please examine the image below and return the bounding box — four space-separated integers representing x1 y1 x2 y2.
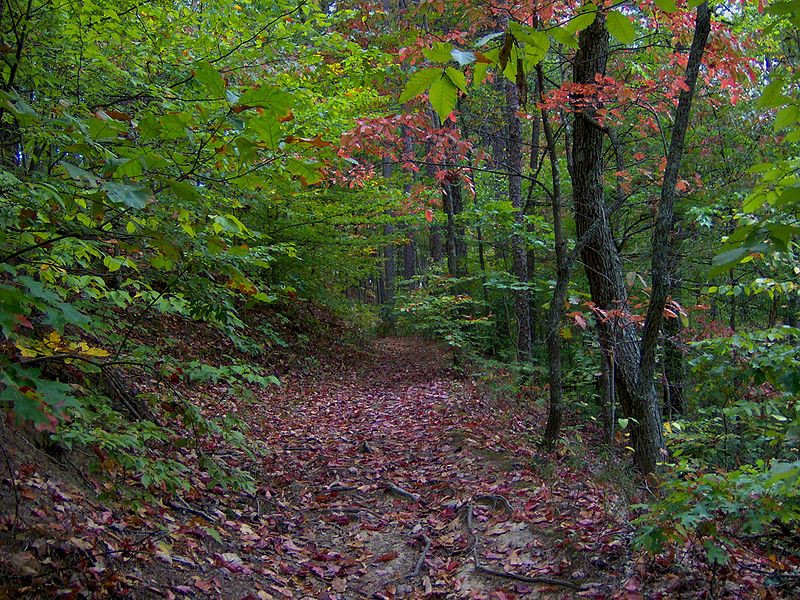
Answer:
227 338 629 598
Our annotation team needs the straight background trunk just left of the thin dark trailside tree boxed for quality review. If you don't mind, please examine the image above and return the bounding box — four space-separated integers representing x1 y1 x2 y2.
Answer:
504 81 531 360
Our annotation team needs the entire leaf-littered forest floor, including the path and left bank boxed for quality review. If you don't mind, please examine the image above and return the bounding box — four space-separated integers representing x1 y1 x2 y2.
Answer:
0 328 780 600
